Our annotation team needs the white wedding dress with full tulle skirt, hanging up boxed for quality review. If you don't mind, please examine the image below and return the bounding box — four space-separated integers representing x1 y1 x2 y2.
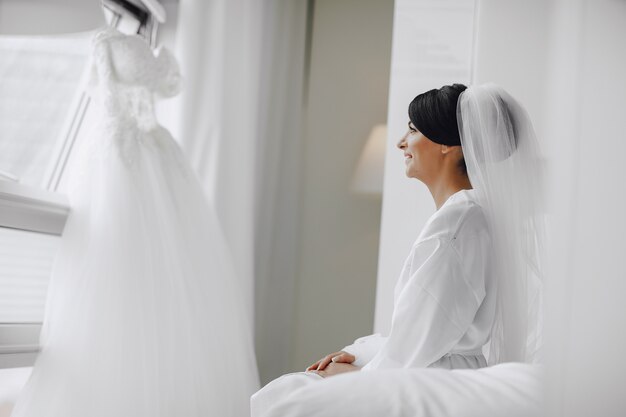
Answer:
13 29 258 417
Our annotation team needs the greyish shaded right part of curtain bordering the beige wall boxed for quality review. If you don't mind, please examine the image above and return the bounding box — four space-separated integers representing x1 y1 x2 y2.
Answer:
249 0 308 382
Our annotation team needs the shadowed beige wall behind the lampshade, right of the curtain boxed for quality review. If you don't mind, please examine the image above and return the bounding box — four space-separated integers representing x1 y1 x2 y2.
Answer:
291 0 393 370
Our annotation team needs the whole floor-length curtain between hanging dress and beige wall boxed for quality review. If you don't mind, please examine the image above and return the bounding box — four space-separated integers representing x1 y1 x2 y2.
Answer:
174 0 309 380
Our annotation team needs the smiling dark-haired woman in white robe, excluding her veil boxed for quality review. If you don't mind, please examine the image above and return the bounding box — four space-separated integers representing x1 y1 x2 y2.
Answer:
320 84 495 369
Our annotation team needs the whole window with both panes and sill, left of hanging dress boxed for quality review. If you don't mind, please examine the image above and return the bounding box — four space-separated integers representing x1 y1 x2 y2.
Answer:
0 33 91 368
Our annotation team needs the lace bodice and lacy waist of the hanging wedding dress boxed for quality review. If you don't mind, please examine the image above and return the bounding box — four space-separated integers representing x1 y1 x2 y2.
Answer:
77 27 190 174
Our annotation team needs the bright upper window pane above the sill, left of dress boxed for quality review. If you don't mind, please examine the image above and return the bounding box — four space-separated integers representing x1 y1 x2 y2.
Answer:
0 33 90 188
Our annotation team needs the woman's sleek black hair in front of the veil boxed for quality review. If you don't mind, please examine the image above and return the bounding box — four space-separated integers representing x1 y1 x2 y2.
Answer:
409 84 467 175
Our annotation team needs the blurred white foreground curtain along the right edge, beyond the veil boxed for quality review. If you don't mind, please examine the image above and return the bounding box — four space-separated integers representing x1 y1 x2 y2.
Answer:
545 0 626 417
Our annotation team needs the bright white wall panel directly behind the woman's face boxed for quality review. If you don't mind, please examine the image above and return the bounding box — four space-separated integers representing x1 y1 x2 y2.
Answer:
375 0 474 334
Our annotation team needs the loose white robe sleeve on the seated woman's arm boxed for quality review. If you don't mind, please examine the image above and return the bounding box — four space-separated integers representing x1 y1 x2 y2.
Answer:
364 235 486 370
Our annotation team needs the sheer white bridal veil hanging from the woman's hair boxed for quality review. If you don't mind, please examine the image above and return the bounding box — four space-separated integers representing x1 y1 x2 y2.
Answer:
457 83 545 364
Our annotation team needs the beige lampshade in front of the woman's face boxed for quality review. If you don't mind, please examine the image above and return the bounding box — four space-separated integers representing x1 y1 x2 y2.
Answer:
351 124 387 196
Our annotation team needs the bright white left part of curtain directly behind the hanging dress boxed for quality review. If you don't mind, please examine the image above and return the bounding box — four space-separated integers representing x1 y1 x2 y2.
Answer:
174 0 261 322
